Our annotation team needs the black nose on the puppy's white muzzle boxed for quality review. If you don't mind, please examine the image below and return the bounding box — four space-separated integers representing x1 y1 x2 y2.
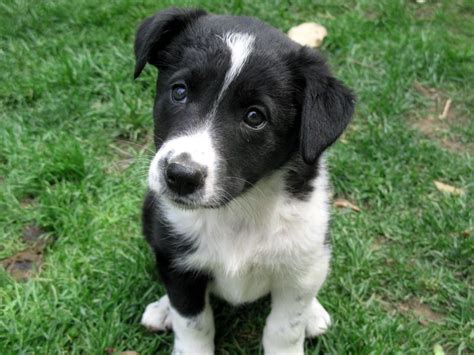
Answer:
165 163 206 196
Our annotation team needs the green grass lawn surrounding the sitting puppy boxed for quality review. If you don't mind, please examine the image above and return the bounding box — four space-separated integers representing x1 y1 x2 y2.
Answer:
0 0 474 354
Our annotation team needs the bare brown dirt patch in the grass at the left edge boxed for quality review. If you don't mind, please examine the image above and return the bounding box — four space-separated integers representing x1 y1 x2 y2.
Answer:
0 224 53 281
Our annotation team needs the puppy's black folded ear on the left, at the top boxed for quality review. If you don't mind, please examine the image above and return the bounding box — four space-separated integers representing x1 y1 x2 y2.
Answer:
134 8 206 79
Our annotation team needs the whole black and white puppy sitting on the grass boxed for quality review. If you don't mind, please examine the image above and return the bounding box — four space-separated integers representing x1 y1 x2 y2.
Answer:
135 9 354 354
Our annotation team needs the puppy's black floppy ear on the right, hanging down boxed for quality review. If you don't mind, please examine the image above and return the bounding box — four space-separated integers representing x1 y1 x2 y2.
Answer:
293 47 355 164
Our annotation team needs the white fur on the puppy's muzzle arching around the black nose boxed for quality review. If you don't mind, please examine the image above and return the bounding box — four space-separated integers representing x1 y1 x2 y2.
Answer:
148 127 218 203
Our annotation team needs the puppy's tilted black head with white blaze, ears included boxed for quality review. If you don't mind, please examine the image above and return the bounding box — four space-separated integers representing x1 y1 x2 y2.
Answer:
135 9 354 208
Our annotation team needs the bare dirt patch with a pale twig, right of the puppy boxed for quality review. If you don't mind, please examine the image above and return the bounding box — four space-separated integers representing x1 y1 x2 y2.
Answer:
410 82 474 155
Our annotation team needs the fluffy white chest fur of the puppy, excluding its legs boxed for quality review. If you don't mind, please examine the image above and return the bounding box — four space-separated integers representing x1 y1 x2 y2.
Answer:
164 171 329 304
